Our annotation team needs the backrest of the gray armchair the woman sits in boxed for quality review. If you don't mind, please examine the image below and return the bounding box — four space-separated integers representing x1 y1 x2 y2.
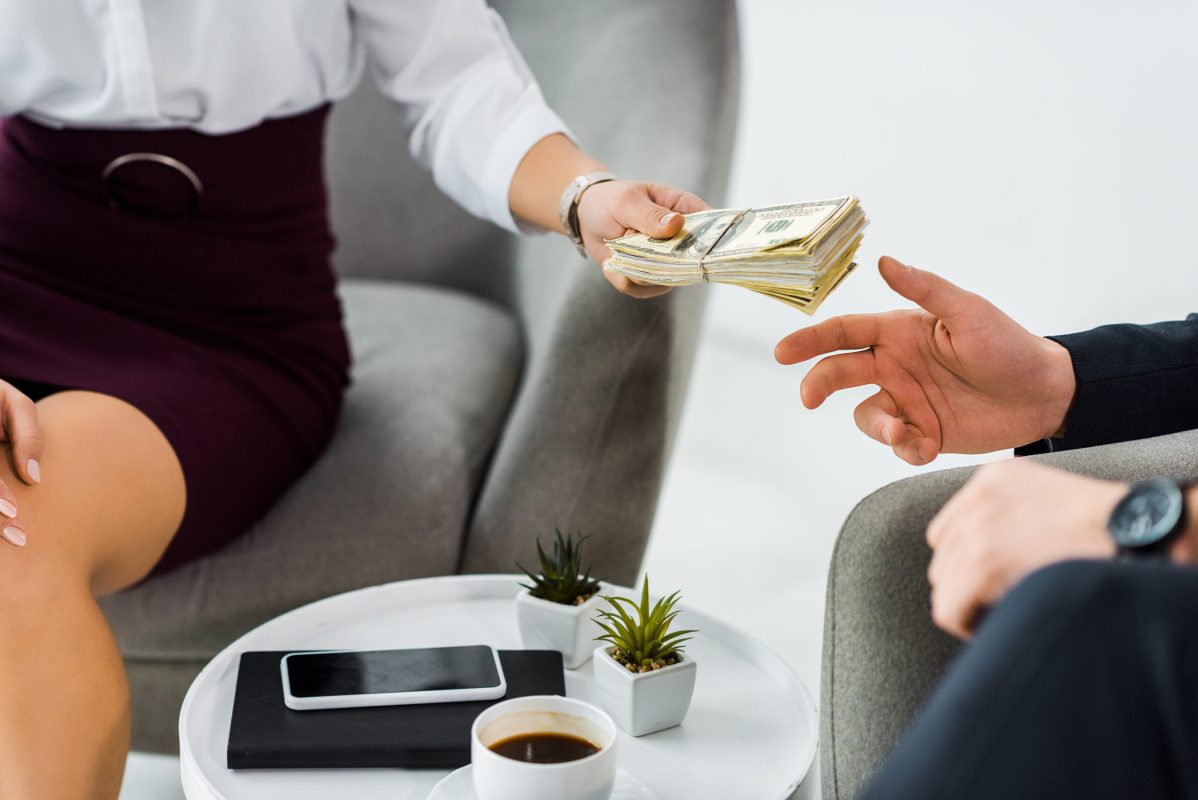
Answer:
328 0 737 304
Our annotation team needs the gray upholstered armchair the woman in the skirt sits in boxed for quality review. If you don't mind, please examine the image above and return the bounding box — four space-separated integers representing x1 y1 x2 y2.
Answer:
103 0 739 752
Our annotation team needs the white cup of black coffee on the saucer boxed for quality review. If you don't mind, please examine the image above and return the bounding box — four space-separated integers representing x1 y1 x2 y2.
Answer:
470 695 616 800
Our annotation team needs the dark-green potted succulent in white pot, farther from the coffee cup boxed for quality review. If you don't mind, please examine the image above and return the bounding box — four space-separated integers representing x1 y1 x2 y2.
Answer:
516 531 601 669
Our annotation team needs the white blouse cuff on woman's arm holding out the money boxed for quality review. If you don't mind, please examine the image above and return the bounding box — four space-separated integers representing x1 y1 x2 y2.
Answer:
479 89 574 234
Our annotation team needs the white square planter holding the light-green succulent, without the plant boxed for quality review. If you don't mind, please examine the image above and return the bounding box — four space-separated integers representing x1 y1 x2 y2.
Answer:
594 644 697 737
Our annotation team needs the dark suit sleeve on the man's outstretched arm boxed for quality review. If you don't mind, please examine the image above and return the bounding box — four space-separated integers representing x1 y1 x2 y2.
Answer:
1015 314 1198 455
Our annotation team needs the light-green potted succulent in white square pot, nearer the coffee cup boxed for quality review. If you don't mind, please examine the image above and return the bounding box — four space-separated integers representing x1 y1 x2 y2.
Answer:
594 575 697 737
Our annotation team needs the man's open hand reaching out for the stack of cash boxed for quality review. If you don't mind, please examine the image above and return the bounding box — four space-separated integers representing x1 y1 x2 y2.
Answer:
774 256 1076 465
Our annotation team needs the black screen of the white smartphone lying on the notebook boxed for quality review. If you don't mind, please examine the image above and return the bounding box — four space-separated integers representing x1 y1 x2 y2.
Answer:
286 646 501 697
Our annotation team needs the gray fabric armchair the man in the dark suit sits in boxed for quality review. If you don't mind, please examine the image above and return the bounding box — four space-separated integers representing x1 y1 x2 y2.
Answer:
819 430 1198 800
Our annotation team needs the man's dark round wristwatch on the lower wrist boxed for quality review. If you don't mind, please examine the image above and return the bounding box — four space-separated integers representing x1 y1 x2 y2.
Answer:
1107 478 1187 558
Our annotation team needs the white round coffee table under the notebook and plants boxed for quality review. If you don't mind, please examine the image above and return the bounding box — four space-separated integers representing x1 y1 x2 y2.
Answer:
179 575 818 800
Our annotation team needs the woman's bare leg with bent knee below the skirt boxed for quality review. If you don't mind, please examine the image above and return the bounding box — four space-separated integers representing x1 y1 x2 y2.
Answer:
0 392 186 800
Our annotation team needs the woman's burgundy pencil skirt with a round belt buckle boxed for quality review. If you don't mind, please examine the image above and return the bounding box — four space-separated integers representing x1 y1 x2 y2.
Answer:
0 107 350 572
